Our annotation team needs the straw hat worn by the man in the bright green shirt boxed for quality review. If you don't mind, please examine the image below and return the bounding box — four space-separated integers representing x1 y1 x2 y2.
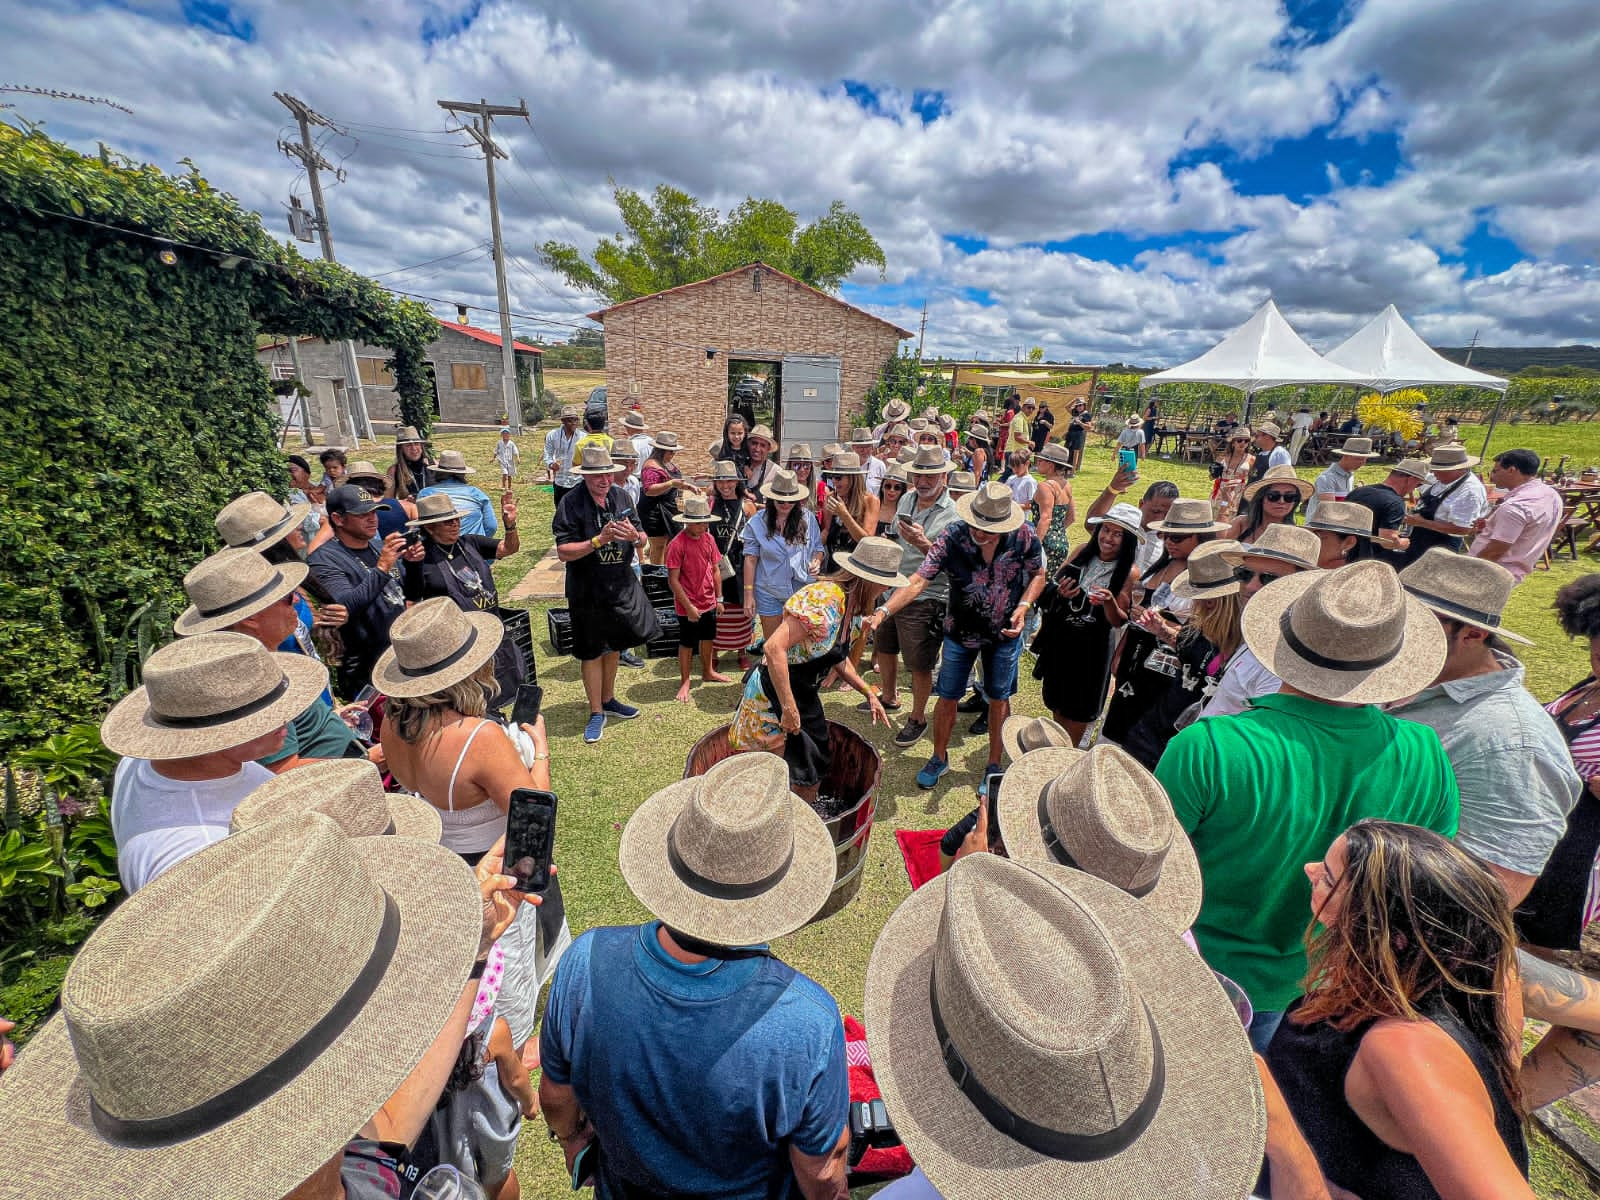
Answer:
1242 558 1446 704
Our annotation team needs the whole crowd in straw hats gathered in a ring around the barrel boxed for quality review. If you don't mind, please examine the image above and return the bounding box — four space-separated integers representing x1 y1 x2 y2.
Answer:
0 398 1600 1200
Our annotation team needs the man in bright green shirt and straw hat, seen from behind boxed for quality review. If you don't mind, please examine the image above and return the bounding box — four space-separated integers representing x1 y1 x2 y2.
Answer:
1155 562 1461 1050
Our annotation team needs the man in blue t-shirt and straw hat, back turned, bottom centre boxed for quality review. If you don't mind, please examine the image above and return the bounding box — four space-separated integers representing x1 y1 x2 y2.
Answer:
539 752 850 1200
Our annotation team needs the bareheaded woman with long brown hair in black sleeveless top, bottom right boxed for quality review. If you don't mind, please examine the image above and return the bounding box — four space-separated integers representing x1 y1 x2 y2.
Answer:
1266 821 1533 1200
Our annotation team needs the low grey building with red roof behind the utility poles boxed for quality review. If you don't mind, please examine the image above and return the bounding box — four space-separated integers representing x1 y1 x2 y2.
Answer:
256 322 544 445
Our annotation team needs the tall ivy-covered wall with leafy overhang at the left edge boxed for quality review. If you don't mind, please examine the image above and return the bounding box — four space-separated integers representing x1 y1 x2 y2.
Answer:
0 125 437 752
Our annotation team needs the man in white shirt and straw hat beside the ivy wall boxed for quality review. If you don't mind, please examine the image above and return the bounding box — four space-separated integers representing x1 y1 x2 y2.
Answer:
101 634 328 893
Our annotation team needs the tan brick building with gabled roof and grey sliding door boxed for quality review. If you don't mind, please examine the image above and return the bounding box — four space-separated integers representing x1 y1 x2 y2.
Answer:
589 262 912 470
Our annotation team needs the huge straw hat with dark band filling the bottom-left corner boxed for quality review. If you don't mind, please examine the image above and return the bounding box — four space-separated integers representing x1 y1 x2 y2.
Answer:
0 813 482 1200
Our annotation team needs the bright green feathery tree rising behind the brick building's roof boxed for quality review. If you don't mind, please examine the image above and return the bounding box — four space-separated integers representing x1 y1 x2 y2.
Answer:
539 184 886 304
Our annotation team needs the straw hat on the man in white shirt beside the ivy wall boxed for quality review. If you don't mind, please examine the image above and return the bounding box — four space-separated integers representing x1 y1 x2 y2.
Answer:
101 634 328 758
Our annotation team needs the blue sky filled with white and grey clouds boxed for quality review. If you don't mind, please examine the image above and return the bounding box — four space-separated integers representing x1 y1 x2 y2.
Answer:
9 0 1600 363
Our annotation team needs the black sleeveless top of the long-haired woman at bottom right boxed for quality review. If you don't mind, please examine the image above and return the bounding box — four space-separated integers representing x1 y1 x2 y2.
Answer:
1266 997 1528 1200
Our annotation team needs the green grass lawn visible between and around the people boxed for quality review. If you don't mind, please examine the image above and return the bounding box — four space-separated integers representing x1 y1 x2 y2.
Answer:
437 419 1600 1200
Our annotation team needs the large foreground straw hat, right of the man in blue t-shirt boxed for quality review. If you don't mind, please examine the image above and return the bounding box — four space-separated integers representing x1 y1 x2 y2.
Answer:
866 857 1267 1200
